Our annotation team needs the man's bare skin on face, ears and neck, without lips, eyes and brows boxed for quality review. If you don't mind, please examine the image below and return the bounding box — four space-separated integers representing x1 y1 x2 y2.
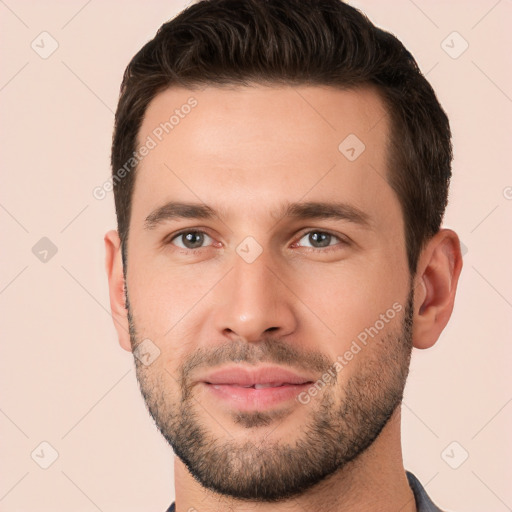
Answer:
105 85 462 512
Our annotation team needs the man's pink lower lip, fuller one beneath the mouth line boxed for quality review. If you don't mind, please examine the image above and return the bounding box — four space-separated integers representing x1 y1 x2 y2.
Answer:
203 382 312 411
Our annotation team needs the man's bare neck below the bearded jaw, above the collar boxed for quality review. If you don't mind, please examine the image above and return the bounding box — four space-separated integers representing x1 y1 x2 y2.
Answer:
174 407 416 512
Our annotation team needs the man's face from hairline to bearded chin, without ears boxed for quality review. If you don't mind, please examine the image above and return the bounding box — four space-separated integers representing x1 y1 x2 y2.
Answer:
126 86 412 501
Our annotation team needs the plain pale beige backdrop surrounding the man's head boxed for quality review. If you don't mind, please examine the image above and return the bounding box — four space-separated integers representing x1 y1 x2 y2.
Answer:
0 0 512 512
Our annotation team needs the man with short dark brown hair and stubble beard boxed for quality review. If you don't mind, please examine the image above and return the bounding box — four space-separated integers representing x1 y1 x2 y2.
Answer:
105 0 462 512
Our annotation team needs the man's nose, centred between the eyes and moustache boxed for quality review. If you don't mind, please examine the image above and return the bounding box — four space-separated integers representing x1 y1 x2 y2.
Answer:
214 251 297 342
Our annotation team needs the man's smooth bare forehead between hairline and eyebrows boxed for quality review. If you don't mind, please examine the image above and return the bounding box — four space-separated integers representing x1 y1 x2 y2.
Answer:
132 85 397 230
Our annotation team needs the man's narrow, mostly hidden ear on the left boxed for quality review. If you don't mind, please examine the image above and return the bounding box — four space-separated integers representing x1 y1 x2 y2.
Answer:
104 230 132 352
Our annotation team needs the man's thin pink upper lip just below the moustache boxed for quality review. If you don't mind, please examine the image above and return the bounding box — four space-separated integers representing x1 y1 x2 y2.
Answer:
200 366 312 386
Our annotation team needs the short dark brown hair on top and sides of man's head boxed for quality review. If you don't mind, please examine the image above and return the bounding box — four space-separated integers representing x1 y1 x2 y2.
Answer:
111 0 452 275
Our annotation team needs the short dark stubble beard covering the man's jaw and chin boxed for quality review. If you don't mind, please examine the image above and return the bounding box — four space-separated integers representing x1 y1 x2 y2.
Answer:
128 290 413 502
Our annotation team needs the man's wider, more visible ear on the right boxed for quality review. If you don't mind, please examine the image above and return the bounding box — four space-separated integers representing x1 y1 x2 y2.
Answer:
413 229 462 349
